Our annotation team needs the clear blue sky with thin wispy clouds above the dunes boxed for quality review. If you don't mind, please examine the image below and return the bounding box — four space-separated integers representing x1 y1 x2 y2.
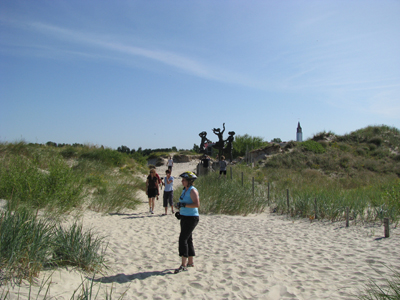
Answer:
0 0 400 149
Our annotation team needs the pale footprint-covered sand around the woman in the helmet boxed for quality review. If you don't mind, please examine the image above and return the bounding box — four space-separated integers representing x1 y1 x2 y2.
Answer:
3 162 400 300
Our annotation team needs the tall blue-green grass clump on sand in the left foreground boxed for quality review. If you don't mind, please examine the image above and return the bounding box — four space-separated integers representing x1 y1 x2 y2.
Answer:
0 208 107 282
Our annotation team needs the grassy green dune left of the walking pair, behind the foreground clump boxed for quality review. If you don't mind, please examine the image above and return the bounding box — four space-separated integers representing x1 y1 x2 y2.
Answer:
0 142 146 217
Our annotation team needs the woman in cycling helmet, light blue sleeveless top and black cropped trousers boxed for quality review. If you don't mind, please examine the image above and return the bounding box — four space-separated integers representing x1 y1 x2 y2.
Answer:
175 172 200 274
